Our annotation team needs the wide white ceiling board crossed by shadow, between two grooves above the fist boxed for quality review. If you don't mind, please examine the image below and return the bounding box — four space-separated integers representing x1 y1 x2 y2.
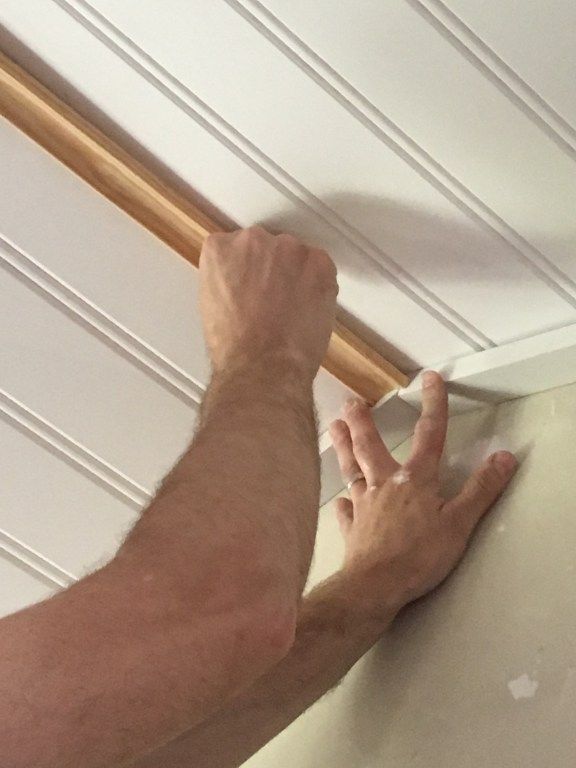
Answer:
55 0 576 345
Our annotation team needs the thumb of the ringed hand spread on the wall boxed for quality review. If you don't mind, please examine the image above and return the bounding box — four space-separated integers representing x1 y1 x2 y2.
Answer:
447 451 518 530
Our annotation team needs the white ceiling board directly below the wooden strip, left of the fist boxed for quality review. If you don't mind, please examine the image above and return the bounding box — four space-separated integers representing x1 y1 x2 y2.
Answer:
0 119 208 392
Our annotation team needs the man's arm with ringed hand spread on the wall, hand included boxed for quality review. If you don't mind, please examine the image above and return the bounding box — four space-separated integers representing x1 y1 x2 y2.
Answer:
137 373 516 768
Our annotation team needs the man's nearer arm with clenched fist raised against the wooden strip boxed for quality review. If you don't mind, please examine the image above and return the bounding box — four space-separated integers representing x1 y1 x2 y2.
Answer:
0 230 337 768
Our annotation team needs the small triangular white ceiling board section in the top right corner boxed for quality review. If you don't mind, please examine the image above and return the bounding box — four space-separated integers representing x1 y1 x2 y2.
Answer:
444 0 576 130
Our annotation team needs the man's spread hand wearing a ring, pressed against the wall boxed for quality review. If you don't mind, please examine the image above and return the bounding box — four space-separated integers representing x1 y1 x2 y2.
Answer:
331 372 516 618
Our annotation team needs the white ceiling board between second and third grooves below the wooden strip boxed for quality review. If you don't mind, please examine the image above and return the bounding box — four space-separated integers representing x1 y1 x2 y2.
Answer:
0 420 138 578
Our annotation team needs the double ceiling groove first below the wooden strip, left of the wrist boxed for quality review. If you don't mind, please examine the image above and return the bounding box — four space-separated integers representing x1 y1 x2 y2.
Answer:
0 234 204 407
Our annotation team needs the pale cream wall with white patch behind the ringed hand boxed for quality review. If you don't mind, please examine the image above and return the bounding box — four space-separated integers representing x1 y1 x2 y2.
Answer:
246 385 576 768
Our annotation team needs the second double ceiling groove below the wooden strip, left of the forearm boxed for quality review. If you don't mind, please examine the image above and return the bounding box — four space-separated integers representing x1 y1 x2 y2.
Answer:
0 389 153 509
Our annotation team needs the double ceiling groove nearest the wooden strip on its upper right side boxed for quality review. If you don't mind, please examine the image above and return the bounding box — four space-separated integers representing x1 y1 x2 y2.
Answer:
53 0 490 351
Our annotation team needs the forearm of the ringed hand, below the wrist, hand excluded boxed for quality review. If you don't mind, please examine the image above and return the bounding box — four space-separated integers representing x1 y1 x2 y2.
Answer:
136 571 394 768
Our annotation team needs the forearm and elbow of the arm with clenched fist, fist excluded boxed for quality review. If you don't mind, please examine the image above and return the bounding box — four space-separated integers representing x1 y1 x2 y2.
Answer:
0 360 318 768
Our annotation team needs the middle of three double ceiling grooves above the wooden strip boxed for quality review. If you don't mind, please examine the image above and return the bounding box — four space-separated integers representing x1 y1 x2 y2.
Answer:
223 0 576 307
